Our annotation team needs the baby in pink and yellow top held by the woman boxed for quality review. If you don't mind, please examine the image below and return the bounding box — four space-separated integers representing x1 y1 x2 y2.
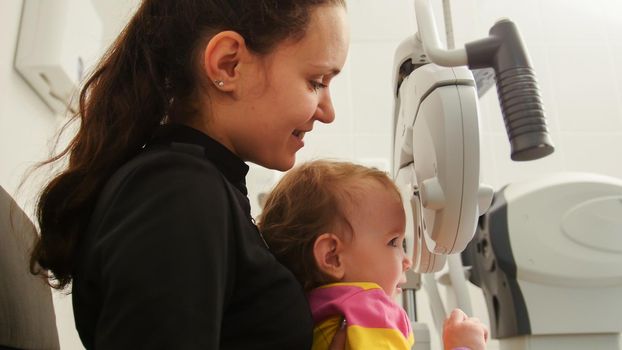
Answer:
259 161 487 350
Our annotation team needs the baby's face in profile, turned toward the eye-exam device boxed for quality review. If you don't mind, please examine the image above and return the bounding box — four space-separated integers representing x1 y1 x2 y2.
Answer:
341 181 412 296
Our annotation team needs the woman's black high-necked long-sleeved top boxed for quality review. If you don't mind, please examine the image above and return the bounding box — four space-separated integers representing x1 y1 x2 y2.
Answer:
73 125 313 350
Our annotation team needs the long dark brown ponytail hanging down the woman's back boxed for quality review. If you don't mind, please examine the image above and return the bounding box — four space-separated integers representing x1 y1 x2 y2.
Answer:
30 2 176 289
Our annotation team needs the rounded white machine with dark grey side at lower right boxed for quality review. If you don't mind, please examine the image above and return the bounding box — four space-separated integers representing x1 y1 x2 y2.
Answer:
462 173 622 350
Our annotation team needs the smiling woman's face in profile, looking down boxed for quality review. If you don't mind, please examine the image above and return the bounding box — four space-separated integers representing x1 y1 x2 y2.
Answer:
214 5 349 171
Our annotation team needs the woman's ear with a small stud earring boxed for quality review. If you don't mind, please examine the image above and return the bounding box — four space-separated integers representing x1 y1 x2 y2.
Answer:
203 30 248 92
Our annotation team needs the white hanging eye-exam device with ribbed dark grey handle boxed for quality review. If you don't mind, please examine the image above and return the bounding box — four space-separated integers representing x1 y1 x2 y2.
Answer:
392 0 604 349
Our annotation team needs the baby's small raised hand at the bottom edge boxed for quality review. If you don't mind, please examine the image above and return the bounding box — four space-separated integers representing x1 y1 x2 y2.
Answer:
443 309 488 350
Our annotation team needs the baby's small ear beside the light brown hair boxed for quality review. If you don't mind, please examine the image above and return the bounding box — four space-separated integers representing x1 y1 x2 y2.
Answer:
313 233 345 281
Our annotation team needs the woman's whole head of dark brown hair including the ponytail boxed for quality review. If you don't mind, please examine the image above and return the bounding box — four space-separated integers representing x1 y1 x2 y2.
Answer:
30 0 345 289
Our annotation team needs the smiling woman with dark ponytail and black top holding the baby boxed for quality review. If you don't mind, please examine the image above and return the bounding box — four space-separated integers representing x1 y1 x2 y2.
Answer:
31 0 348 349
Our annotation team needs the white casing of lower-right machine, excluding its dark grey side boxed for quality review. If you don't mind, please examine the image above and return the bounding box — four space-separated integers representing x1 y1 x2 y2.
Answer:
504 173 622 334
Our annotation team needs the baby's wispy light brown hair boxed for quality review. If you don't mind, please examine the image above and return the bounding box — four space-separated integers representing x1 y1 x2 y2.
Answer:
258 160 401 291
